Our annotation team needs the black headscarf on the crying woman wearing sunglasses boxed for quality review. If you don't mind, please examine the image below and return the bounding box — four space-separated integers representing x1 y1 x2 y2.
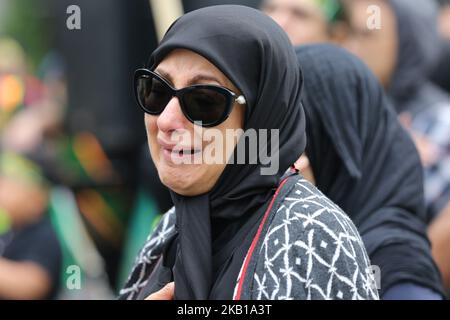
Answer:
150 5 306 299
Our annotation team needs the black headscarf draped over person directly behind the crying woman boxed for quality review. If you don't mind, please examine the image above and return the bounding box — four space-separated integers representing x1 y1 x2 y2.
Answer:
297 45 442 294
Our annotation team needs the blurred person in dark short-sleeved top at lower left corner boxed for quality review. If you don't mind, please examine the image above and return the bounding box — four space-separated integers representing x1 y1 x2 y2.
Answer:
0 151 62 299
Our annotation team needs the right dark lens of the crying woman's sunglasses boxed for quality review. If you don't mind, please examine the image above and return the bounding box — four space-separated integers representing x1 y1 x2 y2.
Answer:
183 88 229 126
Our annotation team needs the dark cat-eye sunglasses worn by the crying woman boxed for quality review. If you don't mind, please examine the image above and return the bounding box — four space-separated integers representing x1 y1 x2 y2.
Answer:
134 69 246 127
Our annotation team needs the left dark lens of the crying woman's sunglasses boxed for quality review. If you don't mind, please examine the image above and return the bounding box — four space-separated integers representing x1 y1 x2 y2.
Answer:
136 75 172 115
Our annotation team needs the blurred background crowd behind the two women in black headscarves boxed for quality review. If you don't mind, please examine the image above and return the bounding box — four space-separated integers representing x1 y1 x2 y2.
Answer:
0 0 450 299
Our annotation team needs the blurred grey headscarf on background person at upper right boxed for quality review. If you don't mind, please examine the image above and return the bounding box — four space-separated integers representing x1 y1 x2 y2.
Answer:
388 0 446 113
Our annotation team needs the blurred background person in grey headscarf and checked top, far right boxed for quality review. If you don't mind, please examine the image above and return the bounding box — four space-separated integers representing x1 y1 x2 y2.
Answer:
341 0 450 289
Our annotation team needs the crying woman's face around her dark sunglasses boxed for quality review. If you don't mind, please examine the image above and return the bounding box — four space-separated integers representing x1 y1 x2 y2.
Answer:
145 49 245 196
